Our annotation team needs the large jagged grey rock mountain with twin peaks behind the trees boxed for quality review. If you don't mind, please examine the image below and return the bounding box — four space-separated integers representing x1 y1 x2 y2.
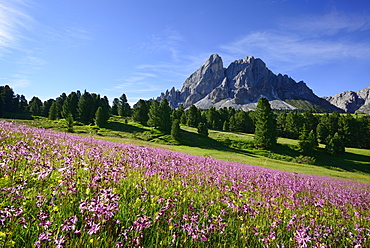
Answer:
157 54 339 111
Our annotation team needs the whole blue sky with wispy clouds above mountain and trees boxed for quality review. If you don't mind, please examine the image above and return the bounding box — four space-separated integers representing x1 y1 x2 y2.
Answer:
0 0 370 103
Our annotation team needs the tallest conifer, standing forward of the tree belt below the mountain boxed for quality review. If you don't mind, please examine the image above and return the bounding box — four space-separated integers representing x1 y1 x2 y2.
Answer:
254 97 277 149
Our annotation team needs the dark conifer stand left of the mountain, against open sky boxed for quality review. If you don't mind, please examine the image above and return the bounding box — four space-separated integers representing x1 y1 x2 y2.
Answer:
0 85 131 126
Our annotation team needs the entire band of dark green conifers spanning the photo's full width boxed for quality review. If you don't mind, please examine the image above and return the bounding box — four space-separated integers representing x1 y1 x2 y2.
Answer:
0 85 370 154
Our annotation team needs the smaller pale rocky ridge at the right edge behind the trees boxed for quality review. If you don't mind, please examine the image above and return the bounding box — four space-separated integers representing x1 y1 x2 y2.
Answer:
325 87 370 114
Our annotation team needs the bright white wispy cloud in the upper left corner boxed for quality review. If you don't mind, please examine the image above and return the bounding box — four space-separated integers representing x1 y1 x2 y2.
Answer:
0 0 34 56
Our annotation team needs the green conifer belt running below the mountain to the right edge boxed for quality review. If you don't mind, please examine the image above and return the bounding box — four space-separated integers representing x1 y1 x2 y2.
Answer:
132 97 370 151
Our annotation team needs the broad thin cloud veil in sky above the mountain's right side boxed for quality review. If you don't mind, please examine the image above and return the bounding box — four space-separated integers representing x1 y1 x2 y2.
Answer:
221 12 370 72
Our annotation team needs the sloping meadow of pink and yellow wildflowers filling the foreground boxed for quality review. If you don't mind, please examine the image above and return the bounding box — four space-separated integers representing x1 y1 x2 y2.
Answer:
0 121 370 248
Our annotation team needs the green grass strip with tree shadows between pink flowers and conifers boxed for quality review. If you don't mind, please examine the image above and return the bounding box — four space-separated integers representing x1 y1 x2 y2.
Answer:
9 117 370 182
